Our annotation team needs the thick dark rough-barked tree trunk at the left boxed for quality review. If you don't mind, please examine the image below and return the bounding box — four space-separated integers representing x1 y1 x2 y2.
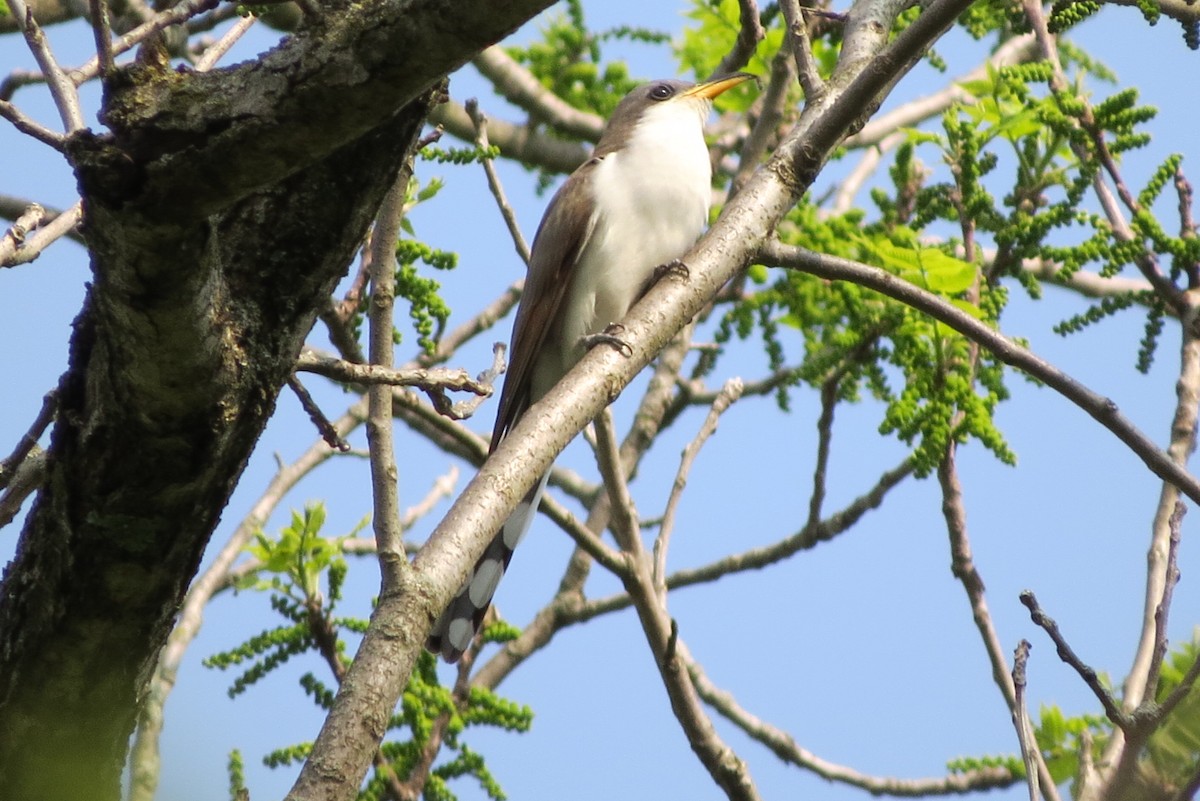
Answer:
0 0 547 801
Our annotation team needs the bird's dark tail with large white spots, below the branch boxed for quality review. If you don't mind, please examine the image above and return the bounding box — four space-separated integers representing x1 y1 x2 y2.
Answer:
425 470 550 662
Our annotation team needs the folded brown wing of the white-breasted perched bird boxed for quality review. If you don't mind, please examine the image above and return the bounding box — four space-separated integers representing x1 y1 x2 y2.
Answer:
490 158 600 451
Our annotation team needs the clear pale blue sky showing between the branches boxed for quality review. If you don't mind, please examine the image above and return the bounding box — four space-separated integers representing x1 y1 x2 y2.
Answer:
0 0 1200 801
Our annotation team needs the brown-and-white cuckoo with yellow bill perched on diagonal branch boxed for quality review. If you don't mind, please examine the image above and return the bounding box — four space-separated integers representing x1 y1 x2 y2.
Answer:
426 72 754 662
